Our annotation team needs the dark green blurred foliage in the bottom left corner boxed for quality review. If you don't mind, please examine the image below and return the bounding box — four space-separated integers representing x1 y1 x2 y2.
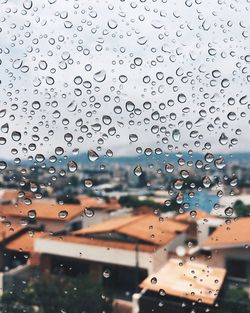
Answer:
0 276 110 313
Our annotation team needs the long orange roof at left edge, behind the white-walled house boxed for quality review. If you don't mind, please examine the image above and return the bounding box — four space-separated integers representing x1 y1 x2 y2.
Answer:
0 200 83 221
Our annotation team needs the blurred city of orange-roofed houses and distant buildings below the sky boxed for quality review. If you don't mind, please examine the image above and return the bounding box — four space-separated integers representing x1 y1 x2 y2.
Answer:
0 150 250 313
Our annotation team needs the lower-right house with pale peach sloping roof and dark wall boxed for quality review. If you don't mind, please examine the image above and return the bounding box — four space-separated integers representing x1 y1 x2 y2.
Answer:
133 258 226 313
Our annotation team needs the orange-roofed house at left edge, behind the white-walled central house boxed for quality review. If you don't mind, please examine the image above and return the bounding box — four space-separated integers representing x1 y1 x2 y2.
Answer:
0 199 83 232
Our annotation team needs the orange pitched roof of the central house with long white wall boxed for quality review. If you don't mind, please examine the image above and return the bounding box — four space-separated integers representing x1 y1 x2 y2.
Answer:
73 214 188 245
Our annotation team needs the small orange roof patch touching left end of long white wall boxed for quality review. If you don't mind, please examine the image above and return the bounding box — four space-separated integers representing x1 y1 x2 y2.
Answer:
6 232 45 253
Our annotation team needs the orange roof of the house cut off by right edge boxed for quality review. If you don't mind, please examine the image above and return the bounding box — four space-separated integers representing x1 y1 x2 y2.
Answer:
202 217 250 248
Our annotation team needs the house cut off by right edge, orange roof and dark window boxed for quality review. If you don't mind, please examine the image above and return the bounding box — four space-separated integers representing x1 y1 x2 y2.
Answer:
201 217 250 294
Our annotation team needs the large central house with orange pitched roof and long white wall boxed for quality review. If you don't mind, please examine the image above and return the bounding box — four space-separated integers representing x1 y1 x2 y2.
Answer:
35 214 187 294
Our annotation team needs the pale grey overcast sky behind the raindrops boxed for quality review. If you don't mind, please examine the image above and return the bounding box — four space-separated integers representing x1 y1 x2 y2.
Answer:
0 0 250 159
